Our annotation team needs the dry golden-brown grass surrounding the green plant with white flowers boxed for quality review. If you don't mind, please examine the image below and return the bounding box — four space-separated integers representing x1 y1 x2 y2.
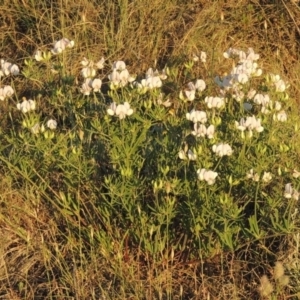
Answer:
0 0 300 299
